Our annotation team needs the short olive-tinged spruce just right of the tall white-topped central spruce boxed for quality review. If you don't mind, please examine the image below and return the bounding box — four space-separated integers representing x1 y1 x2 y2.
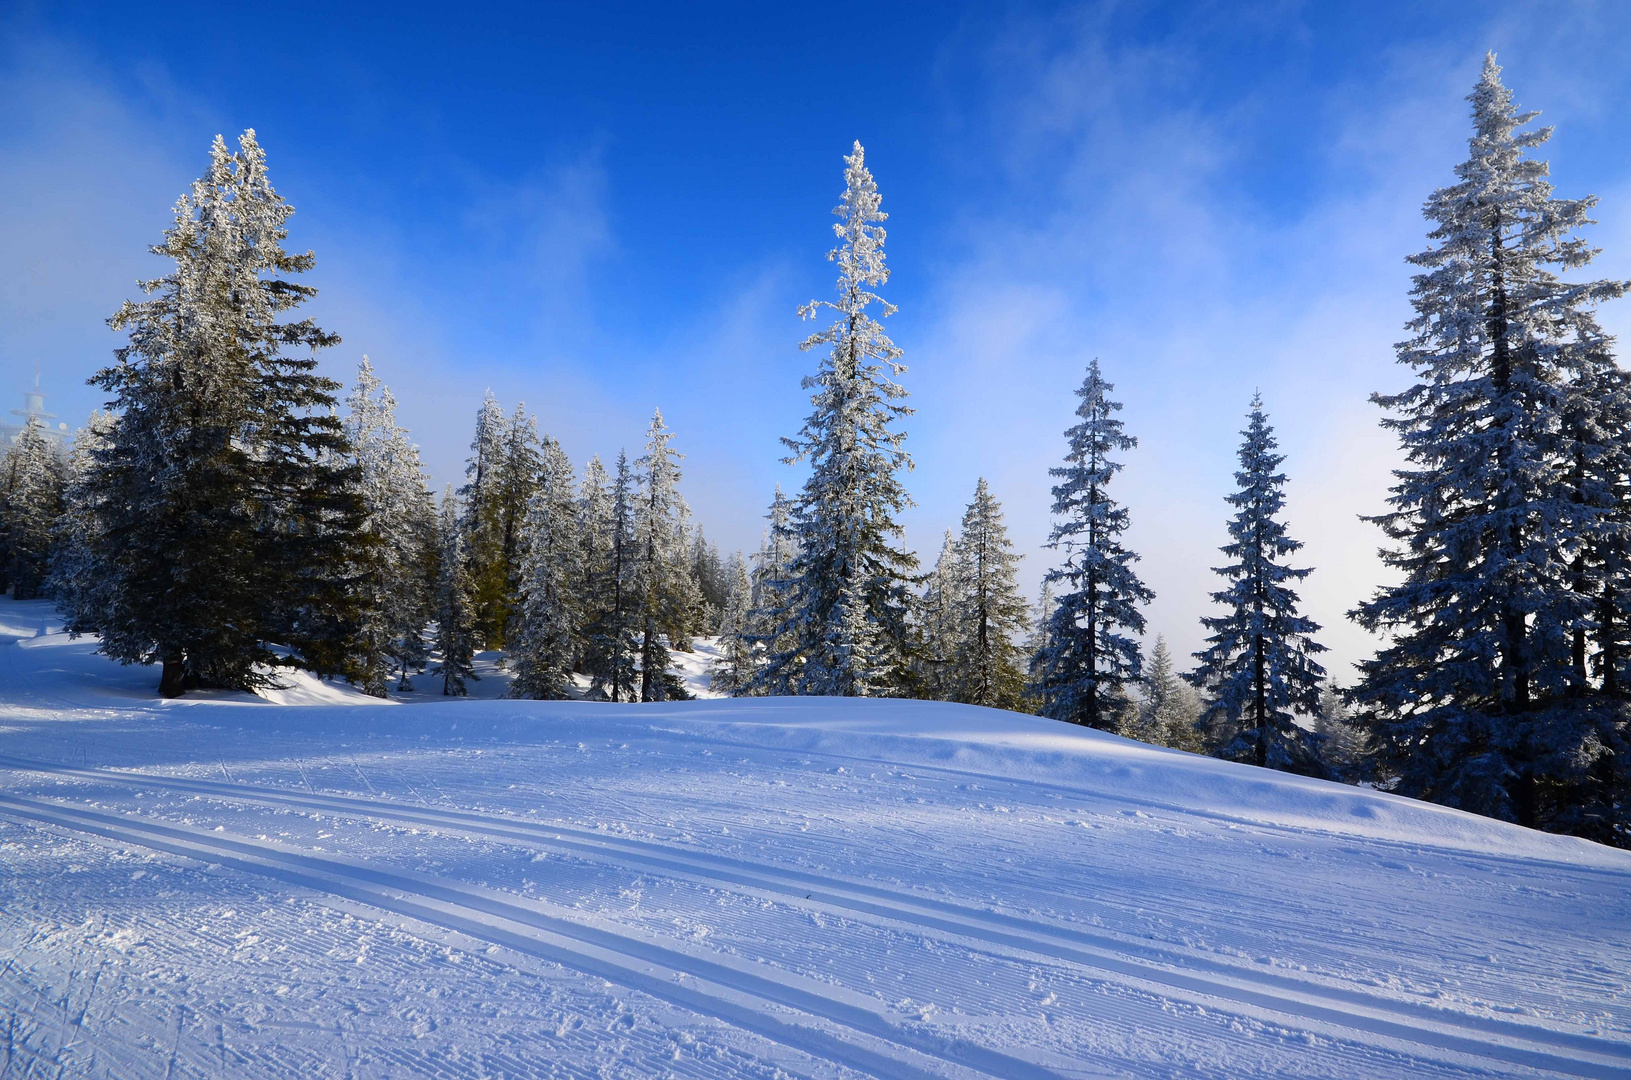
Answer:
954 476 1029 710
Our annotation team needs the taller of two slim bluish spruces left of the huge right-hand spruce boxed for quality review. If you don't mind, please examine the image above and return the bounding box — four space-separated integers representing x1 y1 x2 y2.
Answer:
1031 359 1155 731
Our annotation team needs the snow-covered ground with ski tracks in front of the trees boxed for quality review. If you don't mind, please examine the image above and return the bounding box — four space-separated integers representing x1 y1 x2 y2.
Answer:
0 600 1631 1080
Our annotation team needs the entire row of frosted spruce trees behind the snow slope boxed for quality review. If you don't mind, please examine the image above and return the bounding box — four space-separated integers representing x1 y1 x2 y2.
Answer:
9 55 1631 843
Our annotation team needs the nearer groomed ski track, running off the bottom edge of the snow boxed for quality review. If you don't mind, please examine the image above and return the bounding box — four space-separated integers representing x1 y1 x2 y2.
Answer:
0 793 1082 1080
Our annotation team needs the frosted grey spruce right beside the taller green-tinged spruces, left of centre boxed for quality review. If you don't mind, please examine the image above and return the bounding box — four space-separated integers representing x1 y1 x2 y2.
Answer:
507 437 584 700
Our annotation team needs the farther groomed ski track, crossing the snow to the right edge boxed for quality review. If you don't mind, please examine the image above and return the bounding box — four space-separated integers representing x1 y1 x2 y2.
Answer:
0 755 1631 1075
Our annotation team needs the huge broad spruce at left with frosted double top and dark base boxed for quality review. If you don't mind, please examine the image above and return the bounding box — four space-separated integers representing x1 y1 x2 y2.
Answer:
74 131 359 697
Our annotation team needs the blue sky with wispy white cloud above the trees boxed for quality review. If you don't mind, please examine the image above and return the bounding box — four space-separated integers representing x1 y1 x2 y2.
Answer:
0 3 1631 675
